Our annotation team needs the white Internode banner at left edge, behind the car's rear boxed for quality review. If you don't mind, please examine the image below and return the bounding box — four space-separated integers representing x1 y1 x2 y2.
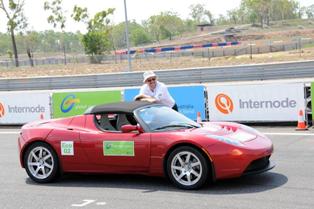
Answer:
0 92 51 124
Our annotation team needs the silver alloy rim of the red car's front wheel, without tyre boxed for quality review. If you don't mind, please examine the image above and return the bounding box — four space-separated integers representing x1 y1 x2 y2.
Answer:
171 151 202 186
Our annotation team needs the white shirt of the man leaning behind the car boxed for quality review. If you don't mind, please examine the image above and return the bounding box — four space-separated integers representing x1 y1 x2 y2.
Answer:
140 81 175 108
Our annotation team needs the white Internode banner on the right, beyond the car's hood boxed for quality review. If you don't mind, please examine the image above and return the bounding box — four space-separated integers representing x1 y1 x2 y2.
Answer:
207 83 305 122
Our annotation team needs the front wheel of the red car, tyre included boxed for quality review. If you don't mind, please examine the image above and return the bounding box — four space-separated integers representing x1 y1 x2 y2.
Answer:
167 146 209 189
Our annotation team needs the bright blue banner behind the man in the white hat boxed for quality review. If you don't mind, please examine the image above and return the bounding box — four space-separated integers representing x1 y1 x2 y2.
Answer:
124 86 205 120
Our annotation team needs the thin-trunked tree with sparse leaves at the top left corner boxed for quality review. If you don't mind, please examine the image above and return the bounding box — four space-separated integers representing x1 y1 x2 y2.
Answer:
0 0 27 67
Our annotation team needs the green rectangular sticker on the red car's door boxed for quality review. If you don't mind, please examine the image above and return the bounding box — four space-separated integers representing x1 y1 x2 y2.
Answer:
103 141 134 156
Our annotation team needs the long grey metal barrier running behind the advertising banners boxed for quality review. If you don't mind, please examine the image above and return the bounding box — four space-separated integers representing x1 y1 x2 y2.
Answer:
0 61 314 91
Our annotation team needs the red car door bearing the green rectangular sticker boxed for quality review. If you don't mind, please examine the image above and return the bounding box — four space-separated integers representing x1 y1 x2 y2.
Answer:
80 114 150 172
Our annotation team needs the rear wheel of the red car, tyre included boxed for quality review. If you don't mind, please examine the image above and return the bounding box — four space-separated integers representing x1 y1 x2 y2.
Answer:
24 142 59 183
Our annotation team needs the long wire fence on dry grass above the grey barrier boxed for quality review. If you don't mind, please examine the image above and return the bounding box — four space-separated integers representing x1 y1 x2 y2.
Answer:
0 39 314 68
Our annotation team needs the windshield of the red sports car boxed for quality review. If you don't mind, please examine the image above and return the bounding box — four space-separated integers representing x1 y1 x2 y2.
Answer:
138 106 200 131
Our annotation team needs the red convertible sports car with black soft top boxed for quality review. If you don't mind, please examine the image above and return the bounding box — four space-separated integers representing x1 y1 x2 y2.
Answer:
18 101 274 189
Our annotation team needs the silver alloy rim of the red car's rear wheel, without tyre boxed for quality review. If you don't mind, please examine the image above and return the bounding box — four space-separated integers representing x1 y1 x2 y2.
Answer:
27 146 54 179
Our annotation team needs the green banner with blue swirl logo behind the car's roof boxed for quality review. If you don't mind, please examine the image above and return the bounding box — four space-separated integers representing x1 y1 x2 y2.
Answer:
52 91 122 118
